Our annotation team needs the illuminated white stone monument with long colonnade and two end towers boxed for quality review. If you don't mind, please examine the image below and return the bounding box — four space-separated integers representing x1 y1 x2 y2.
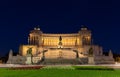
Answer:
7 27 114 64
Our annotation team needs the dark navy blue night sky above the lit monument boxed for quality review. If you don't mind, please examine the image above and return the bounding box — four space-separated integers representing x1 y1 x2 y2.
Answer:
0 0 120 56
